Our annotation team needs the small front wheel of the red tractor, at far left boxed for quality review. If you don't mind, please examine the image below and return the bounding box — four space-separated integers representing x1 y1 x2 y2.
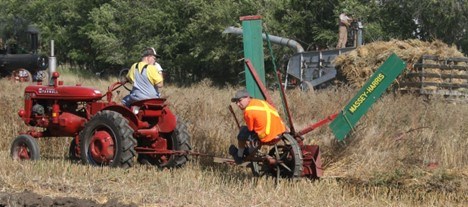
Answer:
10 134 40 160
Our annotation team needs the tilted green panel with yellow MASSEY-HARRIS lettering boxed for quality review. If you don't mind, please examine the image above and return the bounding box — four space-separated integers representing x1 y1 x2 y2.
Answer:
330 54 406 141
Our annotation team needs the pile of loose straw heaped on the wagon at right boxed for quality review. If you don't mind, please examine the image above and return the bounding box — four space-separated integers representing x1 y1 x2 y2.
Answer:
334 39 466 87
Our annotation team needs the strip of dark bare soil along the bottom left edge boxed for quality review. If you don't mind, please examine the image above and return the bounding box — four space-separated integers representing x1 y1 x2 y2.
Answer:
0 191 138 207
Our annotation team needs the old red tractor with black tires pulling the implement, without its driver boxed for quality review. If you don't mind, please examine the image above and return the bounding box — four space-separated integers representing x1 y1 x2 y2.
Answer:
10 72 191 168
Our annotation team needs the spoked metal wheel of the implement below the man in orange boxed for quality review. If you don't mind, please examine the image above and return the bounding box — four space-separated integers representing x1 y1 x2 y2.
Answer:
250 134 303 178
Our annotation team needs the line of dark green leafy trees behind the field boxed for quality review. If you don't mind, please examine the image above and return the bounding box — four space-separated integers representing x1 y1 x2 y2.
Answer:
0 0 468 86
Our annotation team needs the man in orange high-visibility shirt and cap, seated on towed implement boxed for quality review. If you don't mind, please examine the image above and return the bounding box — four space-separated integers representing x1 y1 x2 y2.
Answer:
229 89 287 164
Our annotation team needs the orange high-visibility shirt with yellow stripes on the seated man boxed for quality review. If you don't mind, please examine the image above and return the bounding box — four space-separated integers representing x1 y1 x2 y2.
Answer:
244 99 286 143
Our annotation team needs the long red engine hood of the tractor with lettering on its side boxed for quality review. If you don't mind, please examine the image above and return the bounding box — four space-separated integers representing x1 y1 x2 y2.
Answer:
24 85 103 101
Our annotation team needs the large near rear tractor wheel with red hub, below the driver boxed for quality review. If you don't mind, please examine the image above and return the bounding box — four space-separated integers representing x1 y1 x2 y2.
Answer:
79 110 136 168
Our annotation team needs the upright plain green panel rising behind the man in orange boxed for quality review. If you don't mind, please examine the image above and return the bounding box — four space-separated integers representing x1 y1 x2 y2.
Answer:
240 16 266 99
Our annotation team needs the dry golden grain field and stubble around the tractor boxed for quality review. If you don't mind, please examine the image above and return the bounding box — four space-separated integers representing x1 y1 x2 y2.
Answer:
0 73 468 206
